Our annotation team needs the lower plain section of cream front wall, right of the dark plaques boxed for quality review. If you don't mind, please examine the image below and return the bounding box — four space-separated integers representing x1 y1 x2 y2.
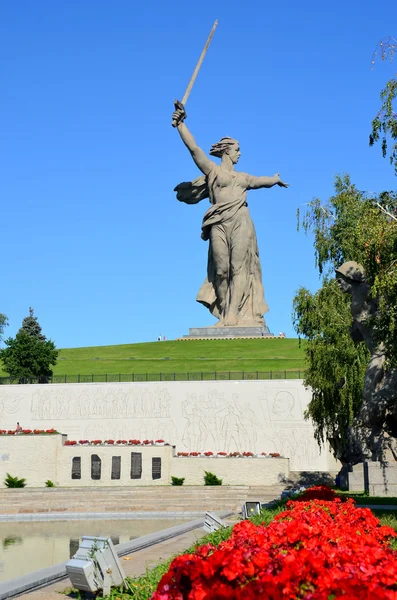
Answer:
171 456 289 485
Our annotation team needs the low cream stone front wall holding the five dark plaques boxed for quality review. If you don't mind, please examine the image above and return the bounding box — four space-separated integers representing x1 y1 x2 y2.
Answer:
0 435 289 487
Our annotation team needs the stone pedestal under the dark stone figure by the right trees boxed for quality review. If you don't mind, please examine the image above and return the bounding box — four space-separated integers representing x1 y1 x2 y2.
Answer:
348 461 397 497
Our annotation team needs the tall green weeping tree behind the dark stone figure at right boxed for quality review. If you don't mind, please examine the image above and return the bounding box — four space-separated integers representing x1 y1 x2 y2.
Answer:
293 175 397 460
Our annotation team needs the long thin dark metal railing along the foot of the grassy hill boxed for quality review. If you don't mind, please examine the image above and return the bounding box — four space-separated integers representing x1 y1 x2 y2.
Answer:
0 370 303 385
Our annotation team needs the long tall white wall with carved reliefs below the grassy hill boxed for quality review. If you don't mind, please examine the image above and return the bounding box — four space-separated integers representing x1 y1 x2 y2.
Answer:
0 380 339 471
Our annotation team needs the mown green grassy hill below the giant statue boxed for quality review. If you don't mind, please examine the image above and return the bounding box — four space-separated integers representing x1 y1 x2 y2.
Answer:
0 338 305 375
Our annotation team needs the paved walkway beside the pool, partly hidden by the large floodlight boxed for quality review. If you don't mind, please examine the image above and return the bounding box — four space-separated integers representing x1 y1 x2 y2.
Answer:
18 529 205 600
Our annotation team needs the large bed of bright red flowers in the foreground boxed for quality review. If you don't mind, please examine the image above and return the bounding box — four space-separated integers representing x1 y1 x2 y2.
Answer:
152 486 397 600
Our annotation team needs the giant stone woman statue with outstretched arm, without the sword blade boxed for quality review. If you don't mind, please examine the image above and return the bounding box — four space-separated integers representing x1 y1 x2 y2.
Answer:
172 102 288 327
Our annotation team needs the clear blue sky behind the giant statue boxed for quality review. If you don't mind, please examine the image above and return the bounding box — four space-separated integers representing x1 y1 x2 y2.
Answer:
0 0 397 347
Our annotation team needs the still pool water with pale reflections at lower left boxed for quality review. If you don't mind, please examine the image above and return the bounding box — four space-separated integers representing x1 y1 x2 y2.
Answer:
0 519 187 581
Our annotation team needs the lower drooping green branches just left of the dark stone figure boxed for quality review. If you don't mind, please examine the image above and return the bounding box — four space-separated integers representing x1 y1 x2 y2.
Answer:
293 279 369 462
